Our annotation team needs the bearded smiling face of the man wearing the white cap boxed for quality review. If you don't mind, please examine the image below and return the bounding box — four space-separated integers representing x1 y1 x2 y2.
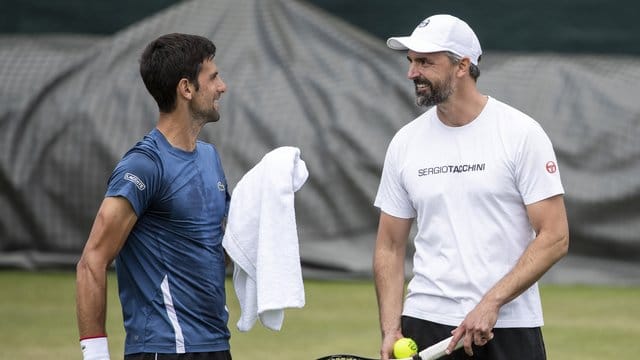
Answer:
407 50 456 106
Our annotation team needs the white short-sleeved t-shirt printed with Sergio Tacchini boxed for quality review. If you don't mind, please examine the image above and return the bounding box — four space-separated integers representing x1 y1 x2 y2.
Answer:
375 98 564 327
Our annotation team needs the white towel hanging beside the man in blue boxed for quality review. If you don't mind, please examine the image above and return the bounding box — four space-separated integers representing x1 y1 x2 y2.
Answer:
222 146 309 331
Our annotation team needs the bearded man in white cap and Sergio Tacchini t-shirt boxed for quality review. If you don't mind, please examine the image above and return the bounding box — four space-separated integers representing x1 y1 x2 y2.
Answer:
374 15 569 360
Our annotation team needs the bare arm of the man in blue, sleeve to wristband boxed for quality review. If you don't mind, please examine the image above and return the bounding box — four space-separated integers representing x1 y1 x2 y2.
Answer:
76 197 137 338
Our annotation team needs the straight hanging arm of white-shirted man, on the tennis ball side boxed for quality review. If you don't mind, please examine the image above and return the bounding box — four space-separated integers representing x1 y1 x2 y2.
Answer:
373 212 413 360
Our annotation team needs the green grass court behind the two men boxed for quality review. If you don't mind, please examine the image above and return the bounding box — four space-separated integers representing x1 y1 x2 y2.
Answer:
0 271 640 360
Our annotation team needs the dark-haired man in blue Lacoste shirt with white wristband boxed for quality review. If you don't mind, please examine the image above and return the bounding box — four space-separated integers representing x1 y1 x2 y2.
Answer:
76 34 231 360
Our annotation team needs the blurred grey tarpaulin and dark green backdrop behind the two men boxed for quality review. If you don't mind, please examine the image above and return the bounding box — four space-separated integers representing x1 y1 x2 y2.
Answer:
0 0 640 284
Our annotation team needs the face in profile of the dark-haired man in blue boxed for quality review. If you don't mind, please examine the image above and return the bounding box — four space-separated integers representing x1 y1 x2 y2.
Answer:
189 59 227 123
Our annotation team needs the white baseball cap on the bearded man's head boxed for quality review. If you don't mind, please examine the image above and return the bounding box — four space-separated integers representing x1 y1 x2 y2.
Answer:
387 15 482 65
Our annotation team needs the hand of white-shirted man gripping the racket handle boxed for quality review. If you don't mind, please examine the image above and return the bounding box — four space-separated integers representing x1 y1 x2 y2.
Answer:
447 301 500 356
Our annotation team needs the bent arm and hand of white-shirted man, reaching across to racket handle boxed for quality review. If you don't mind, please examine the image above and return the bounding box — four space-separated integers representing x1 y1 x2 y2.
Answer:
449 195 569 354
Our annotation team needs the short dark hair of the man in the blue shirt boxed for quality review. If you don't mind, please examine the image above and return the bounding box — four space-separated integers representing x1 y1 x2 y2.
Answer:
140 33 216 112
